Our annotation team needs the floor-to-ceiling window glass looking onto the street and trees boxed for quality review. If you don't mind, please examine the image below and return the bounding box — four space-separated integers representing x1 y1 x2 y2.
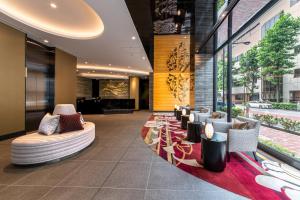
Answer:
215 0 300 162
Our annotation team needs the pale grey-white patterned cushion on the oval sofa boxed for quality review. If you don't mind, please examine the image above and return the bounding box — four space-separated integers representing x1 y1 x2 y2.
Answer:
38 113 59 135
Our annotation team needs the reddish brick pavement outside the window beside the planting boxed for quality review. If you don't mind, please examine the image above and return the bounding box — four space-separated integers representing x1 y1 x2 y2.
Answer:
260 126 300 157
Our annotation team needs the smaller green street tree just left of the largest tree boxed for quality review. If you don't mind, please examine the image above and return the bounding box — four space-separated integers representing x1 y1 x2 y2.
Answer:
239 46 260 99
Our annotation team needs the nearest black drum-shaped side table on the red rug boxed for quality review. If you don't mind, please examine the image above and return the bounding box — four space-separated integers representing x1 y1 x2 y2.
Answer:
201 133 226 172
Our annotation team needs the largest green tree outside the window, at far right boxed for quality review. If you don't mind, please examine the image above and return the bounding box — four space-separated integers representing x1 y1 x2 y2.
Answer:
258 14 300 102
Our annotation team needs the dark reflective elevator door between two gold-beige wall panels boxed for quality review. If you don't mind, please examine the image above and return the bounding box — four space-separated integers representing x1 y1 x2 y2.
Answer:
26 39 54 131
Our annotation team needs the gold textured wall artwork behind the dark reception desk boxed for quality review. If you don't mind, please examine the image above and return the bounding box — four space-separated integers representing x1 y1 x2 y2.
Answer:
99 80 129 99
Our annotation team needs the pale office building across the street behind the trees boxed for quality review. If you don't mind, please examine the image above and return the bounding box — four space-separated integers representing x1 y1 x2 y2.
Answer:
232 0 300 104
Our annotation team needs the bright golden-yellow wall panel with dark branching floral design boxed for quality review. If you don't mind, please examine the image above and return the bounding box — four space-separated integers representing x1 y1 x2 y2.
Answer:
153 35 194 111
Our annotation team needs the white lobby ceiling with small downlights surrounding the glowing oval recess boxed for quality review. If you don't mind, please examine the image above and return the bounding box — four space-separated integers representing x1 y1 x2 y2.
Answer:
0 0 152 77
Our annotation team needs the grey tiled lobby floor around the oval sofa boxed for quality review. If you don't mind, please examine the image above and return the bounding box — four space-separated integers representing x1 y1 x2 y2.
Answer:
0 112 246 200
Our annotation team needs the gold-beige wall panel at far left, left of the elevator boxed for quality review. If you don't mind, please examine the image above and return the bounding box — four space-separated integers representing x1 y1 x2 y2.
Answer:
0 23 25 135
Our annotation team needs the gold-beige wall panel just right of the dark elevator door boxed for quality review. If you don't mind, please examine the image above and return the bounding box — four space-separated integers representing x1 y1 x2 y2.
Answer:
55 48 77 106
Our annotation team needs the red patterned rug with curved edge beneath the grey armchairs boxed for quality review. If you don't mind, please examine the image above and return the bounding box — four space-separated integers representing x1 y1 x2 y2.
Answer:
141 114 300 200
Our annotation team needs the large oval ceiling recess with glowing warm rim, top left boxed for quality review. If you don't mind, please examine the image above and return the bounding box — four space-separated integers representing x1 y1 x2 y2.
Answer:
0 0 104 39
